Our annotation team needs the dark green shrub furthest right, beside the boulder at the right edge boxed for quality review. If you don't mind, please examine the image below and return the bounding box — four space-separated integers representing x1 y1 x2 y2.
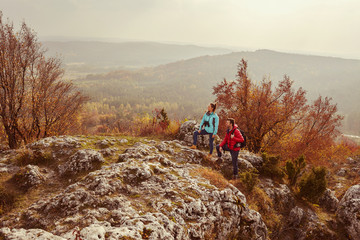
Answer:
299 167 327 203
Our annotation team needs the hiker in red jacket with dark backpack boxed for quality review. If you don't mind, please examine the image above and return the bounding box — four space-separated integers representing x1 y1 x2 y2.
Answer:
216 118 244 179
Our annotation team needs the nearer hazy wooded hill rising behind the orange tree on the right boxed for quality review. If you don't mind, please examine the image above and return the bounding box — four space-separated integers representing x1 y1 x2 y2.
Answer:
76 50 360 134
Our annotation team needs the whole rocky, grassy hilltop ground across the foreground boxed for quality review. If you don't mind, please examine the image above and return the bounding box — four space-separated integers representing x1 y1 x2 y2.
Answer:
0 121 360 240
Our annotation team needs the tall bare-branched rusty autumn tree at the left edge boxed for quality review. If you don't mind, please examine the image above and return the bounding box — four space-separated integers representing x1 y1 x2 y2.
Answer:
0 12 87 148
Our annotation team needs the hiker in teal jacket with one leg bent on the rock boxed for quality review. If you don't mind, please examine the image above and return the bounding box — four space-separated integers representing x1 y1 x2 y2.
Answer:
190 103 219 158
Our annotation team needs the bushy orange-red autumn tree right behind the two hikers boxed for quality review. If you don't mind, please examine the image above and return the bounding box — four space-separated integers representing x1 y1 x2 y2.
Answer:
213 59 342 162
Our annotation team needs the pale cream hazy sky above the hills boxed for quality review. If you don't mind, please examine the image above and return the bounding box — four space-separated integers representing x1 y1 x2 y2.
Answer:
0 0 360 59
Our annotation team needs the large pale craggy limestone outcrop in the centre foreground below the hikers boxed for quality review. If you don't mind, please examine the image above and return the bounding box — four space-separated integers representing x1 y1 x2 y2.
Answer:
0 138 267 240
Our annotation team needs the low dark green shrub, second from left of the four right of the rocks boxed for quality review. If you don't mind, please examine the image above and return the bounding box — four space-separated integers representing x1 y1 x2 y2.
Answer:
260 153 285 181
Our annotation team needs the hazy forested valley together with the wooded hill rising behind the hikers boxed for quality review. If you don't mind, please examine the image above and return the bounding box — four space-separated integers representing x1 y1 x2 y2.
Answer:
73 50 360 138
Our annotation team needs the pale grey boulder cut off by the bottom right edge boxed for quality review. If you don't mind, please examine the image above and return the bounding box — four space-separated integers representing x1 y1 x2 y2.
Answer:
336 184 360 240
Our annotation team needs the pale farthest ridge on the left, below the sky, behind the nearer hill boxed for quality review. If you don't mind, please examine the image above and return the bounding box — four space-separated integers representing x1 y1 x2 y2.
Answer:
43 41 231 67
